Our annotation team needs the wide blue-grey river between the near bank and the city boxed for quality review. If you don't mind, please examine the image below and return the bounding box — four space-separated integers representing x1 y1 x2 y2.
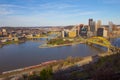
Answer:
0 39 120 72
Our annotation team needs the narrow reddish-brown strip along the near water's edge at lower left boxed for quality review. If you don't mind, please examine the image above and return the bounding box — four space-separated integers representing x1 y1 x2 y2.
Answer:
0 60 57 80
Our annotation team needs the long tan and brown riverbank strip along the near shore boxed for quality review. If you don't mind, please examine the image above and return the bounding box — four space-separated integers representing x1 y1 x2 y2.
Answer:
0 53 110 78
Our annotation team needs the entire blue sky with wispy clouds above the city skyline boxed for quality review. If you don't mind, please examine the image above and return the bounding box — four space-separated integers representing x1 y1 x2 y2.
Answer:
0 0 120 27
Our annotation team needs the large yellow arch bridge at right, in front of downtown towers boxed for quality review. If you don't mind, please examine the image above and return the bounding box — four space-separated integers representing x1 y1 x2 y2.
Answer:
86 37 120 53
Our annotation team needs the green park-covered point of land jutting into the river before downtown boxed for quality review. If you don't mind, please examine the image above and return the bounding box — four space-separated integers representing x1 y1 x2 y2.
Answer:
39 38 85 48
